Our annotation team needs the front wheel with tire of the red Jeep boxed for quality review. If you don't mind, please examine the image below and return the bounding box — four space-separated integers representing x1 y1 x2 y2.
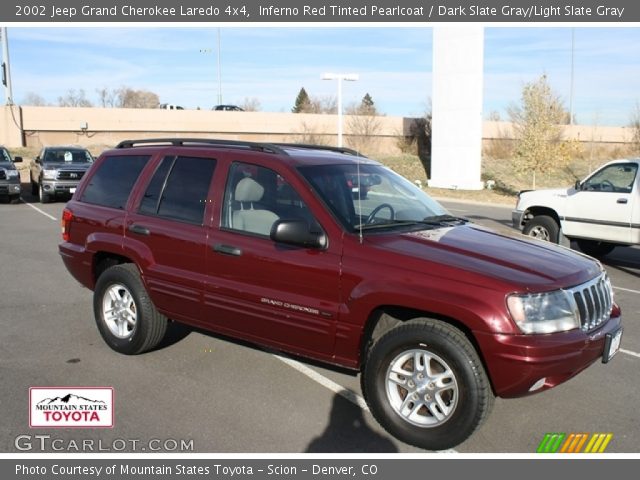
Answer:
361 318 494 450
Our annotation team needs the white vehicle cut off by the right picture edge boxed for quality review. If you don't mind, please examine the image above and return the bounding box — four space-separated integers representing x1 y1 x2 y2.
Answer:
512 159 640 257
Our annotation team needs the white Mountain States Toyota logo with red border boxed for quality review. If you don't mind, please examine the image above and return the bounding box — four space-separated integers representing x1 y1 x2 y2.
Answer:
29 387 113 428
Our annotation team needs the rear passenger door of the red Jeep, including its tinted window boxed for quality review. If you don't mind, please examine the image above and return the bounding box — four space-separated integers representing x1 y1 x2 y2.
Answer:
125 154 217 323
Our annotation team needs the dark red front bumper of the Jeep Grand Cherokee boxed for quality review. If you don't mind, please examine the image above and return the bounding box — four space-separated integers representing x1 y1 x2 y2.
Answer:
476 307 622 397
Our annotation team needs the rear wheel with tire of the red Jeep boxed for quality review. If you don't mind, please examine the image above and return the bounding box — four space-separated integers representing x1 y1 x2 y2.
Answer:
93 263 168 355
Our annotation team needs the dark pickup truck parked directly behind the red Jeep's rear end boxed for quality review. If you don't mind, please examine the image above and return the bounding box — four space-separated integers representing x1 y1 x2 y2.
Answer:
30 146 93 203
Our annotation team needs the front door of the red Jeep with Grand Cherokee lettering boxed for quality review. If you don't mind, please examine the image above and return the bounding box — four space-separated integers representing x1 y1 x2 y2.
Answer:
204 158 341 357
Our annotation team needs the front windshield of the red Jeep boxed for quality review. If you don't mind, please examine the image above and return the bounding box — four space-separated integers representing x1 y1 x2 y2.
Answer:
299 164 448 231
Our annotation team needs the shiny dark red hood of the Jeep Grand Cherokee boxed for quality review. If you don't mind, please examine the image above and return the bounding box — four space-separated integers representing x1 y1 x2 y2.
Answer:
368 224 601 291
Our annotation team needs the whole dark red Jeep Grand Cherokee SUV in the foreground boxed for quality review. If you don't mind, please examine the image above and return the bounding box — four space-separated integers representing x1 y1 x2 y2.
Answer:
60 139 622 450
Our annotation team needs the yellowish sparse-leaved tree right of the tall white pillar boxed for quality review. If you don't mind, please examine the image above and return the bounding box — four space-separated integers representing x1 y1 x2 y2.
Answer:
508 75 573 188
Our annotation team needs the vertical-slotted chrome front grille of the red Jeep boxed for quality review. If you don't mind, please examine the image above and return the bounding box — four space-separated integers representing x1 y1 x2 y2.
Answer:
569 273 613 332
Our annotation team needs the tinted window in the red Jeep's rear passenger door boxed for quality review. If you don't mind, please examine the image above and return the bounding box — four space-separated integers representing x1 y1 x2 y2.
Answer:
139 157 216 225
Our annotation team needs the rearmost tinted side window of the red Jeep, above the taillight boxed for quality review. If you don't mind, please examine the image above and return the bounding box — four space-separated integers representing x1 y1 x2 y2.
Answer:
80 155 150 209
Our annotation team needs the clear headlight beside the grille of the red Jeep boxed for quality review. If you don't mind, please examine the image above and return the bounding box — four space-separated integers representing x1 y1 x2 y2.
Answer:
507 290 580 333
